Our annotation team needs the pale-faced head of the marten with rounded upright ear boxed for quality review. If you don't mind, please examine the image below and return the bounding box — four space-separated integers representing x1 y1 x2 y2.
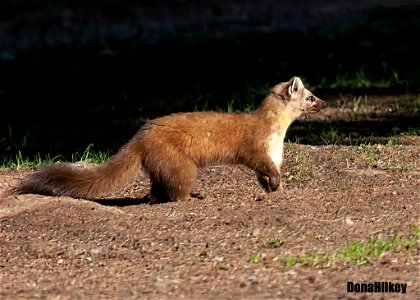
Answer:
270 77 326 114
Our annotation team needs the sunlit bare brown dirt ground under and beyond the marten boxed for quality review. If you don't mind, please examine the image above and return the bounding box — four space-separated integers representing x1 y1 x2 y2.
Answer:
0 95 420 299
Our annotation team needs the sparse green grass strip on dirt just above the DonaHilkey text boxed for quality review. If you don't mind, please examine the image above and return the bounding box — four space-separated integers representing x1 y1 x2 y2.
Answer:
282 227 420 268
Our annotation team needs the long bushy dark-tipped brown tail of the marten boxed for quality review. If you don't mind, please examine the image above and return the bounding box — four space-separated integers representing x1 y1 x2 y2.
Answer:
12 141 141 199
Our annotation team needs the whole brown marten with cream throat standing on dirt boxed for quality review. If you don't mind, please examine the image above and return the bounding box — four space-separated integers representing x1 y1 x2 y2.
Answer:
14 77 325 202
